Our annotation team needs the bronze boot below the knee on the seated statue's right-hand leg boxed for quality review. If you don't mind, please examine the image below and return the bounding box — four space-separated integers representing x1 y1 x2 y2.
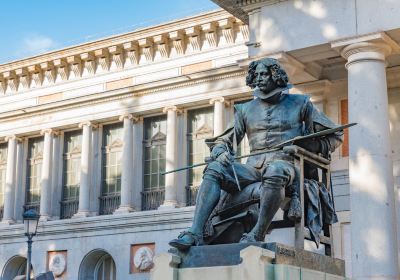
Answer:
240 182 285 243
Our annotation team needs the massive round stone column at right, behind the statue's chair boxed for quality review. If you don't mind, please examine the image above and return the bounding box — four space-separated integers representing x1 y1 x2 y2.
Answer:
332 33 399 279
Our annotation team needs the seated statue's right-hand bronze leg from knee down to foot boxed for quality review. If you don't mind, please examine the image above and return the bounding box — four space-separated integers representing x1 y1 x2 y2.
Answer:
240 161 294 243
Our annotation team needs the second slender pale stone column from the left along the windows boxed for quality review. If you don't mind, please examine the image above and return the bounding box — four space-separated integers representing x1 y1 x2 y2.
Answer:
40 129 54 221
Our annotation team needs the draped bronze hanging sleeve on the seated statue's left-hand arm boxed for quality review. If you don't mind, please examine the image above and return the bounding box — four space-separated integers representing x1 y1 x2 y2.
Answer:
205 104 246 154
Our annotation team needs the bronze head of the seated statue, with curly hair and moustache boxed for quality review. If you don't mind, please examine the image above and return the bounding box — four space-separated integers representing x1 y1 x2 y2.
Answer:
246 58 288 99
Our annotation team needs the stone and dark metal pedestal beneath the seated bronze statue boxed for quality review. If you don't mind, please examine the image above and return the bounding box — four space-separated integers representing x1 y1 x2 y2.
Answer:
150 243 346 280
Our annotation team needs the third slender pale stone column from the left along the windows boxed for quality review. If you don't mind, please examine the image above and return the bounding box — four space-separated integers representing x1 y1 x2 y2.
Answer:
73 121 94 218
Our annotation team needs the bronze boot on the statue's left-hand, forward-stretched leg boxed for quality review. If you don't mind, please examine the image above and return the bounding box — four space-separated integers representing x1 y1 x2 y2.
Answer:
169 175 221 250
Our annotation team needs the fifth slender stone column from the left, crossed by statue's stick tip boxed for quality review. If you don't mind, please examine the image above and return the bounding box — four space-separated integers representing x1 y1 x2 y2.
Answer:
160 106 179 209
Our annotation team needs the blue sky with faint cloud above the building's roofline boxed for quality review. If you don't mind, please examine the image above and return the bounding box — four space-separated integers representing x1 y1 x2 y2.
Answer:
0 0 218 64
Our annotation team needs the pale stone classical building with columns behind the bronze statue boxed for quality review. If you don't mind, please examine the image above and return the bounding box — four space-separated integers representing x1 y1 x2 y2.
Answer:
0 0 400 280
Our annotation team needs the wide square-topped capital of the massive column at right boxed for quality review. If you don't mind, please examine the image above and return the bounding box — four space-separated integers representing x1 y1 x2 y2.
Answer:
331 32 400 67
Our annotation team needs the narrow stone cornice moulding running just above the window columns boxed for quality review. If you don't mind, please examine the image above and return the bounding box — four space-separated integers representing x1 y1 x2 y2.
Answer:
0 66 246 122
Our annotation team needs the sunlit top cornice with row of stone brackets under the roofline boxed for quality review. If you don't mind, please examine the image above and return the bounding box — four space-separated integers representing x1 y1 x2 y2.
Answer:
0 11 249 95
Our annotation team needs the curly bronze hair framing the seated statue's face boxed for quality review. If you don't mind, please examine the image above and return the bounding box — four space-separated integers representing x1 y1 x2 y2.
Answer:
246 58 289 88
